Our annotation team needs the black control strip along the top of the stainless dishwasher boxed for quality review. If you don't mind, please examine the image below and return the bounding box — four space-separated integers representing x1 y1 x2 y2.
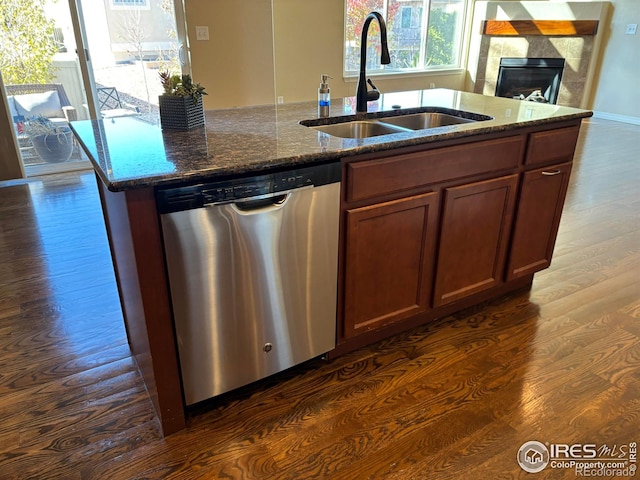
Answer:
156 162 341 214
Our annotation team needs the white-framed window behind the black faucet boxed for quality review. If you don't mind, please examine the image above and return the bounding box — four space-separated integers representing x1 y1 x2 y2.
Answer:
344 0 468 76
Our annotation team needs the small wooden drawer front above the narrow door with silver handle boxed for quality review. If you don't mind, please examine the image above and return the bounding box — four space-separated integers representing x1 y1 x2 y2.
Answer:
524 126 580 165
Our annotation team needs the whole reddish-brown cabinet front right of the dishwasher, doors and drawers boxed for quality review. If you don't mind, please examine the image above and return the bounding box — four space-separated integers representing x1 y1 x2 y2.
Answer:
336 122 580 354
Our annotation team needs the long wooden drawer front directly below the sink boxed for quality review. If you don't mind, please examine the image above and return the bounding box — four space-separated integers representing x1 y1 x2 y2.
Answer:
346 135 524 202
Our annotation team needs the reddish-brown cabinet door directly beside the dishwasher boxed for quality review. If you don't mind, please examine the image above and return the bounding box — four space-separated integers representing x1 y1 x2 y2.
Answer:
344 193 438 338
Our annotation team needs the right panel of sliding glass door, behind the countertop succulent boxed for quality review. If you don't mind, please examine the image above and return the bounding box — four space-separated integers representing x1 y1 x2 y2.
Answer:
80 0 185 123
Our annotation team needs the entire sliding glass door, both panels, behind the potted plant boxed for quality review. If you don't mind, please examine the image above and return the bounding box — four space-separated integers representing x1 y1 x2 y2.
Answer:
0 0 189 176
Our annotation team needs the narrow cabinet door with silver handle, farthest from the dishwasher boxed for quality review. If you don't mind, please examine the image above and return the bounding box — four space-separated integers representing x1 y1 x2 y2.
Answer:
507 162 571 280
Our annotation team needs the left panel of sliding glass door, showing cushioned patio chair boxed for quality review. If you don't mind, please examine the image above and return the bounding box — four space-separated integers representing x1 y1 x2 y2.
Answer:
0 0 89 175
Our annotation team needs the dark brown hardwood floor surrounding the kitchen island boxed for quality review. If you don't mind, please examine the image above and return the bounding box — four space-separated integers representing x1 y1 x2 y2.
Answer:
0 119 640 480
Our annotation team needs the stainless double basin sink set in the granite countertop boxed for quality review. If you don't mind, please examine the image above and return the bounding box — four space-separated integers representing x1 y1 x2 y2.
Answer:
300 110 492 138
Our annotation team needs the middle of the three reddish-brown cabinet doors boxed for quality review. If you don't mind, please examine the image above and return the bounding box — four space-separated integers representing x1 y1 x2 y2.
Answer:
433 175 518 306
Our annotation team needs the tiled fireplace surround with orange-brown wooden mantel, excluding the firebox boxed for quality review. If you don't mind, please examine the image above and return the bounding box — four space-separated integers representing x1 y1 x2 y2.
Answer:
465 0 611 108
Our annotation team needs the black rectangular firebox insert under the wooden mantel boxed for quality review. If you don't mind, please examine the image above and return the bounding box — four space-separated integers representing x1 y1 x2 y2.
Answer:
495 58 565 104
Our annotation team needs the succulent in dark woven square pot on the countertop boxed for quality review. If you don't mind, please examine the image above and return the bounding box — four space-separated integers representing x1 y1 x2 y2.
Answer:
158 71 207 130
